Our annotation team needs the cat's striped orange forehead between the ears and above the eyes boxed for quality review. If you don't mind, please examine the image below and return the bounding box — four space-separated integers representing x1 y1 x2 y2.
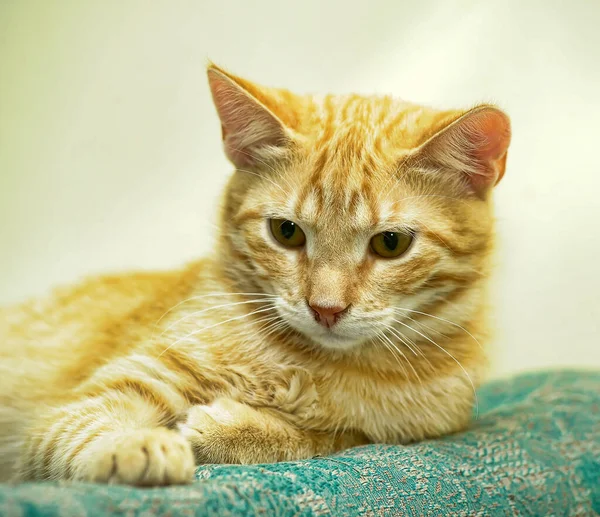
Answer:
246 95 448 231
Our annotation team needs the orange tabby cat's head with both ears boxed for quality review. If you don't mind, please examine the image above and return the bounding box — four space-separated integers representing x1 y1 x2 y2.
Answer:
208 65 510 350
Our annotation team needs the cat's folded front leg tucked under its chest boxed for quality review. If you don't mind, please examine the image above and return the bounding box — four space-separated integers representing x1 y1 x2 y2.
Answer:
180 398 366 464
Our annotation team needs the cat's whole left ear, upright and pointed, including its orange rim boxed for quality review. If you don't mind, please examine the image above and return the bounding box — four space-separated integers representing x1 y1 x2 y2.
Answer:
207 64 291 168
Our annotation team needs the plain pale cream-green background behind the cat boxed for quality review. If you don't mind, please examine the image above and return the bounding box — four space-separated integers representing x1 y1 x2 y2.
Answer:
0 0 600 375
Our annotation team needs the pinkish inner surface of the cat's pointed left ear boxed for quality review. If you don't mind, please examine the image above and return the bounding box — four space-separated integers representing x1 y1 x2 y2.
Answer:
208 70 285 167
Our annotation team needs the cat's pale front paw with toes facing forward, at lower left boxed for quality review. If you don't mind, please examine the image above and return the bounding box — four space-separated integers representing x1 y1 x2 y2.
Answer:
75 428 195 486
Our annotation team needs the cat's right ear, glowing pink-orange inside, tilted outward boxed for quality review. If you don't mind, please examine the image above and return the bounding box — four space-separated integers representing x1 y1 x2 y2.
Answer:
412 105 511 198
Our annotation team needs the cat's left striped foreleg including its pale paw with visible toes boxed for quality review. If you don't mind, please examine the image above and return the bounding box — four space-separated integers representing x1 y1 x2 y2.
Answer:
17 388 195 486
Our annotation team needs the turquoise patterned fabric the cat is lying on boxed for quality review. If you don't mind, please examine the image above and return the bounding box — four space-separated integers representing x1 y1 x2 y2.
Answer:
0 372 600 517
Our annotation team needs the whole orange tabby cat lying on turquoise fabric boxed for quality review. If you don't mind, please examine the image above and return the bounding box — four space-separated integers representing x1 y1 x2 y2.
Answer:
0 64 511 486
